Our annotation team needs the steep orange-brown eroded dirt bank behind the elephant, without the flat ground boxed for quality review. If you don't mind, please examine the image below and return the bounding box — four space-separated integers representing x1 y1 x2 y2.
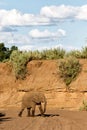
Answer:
0 60 87 109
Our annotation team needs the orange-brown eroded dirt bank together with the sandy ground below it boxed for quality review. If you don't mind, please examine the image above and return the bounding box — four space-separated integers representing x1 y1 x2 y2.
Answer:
0 60 87 130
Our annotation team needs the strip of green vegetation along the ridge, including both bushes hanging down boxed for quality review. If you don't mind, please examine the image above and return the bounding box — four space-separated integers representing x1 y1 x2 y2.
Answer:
0 43 83 83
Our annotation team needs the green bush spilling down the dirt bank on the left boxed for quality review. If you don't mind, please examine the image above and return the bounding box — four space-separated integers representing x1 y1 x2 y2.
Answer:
10 50 29 79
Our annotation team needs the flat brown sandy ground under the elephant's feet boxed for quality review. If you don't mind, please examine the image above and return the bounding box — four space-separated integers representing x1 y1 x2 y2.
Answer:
0 108 87 130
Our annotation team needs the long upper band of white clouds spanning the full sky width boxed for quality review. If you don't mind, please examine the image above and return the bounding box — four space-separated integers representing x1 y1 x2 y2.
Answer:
0 5 87 26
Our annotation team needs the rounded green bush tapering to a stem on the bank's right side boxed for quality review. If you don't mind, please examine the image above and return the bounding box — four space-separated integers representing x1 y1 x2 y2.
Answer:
59 57 81 86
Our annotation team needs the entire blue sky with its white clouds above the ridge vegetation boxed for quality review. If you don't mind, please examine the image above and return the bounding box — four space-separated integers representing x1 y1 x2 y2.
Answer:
0 0 87 50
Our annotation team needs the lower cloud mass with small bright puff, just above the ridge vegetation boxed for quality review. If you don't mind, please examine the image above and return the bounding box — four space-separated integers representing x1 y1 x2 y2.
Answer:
0 29 66 50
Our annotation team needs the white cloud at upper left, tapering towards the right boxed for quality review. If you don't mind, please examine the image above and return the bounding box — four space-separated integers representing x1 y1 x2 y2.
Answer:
0 9 50 26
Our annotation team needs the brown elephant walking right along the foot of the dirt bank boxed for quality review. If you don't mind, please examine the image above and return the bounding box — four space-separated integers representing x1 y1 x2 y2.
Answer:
18 92 47 117
